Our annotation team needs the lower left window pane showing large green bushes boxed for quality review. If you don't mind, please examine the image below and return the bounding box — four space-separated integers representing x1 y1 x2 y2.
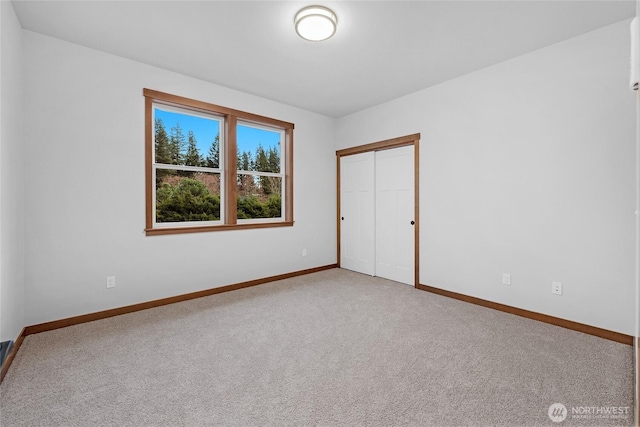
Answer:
156 168 220 223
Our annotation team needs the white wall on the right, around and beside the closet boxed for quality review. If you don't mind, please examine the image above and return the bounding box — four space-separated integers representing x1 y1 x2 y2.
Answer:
336 20 635 335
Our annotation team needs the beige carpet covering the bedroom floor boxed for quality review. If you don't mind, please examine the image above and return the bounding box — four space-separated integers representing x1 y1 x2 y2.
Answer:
0 269 633 427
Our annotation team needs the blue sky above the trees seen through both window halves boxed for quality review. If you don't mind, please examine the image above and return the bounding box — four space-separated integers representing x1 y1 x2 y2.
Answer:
154 108 280 161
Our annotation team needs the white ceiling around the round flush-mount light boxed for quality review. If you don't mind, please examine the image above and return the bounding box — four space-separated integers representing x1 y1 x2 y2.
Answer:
8 0 635 117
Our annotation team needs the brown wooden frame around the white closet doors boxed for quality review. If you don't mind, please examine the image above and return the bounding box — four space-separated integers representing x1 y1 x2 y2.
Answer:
336 133 420 288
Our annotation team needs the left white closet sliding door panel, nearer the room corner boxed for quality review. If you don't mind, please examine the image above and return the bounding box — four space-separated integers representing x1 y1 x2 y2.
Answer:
340 152 375 276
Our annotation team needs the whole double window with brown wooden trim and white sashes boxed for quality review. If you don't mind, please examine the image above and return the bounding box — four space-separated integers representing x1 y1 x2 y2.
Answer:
144 89 294 235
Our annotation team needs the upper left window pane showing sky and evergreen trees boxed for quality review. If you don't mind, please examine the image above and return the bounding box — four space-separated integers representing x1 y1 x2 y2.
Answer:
153 107 220 168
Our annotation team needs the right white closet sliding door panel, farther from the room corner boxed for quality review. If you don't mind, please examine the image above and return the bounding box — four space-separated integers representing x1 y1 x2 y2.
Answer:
375 146 415 286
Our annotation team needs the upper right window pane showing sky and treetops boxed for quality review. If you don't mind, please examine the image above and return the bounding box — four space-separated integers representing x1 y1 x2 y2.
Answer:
236 125 283 173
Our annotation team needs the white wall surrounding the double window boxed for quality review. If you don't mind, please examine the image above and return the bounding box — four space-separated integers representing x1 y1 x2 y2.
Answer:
24 31 336 324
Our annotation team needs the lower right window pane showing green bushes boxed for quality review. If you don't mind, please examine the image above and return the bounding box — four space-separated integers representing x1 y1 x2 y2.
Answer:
236 174 282 219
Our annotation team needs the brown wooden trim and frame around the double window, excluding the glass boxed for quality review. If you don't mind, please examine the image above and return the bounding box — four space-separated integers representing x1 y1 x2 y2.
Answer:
143 88 295 236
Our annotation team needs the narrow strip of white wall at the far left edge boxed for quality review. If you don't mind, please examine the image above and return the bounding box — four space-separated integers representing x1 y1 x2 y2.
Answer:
0 1 24 341
